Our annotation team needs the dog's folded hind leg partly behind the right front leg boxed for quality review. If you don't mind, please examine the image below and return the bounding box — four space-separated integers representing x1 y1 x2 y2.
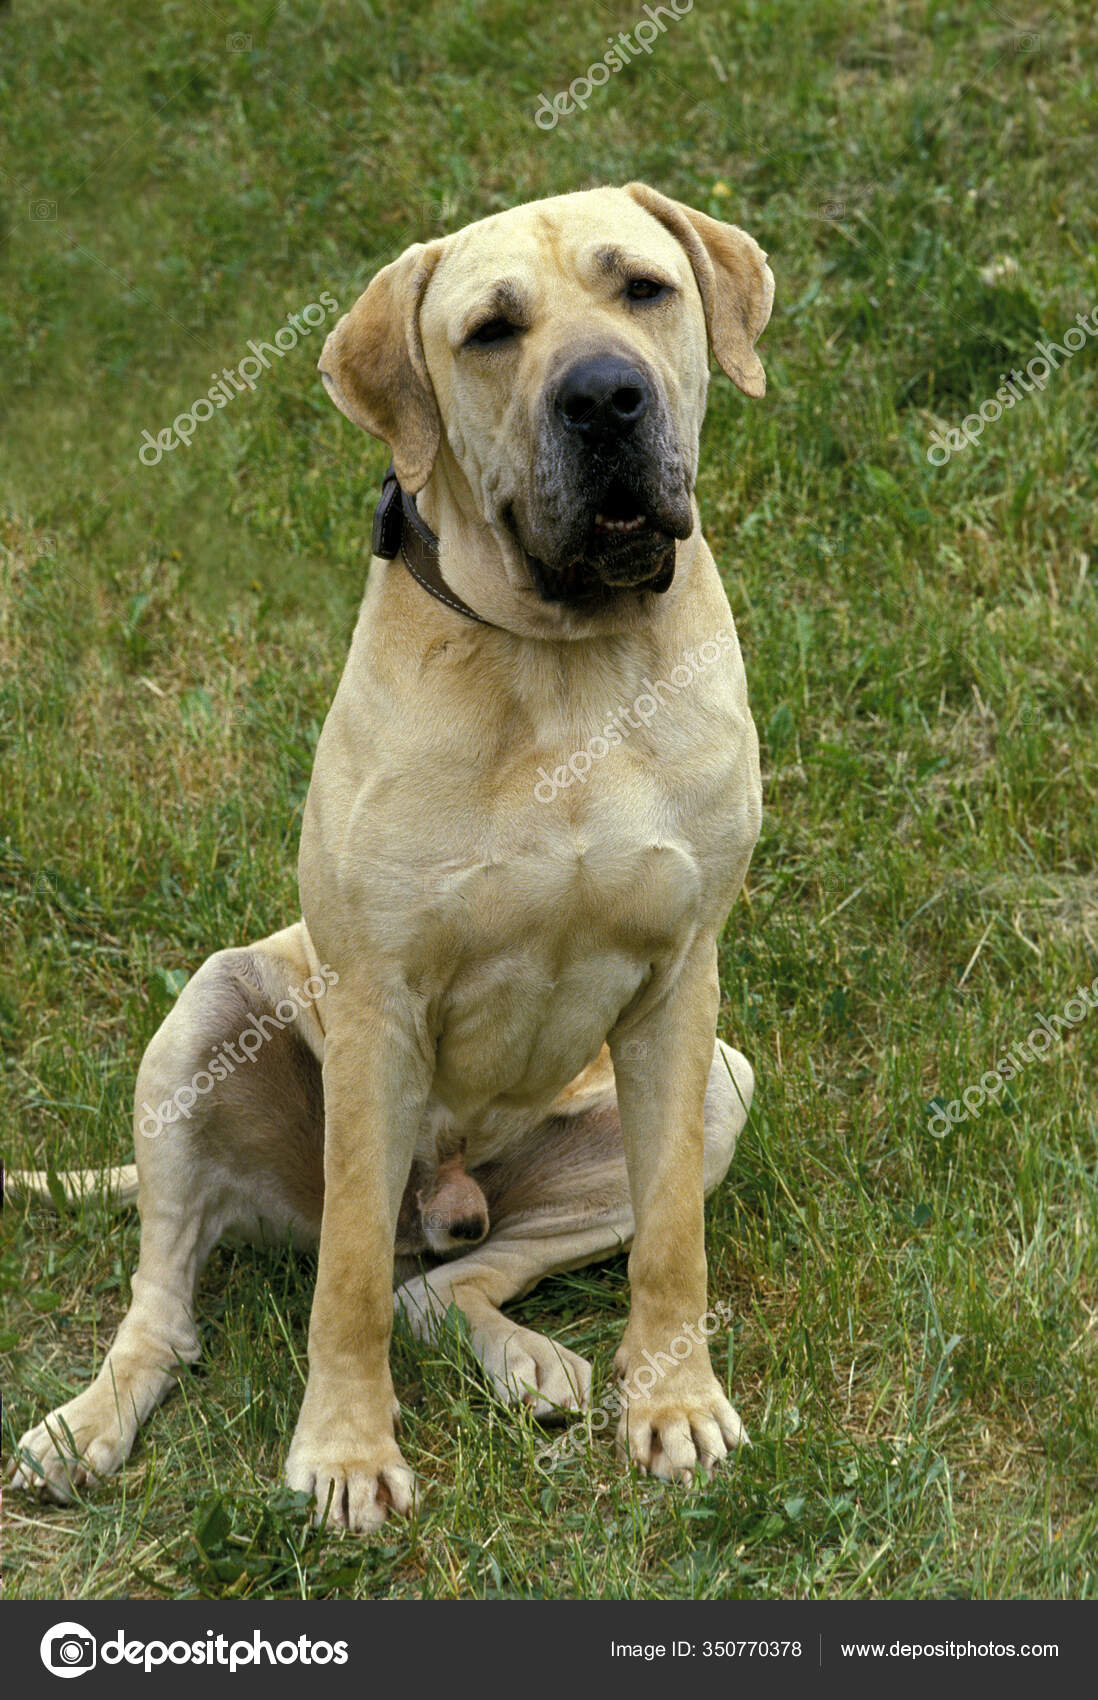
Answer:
394 1040 755 1418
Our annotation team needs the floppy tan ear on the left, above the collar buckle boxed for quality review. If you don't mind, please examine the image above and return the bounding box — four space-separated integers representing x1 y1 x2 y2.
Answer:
316 241 442 495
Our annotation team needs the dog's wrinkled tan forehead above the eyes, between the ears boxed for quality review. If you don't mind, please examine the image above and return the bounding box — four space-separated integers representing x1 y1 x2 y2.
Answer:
422 190 693 347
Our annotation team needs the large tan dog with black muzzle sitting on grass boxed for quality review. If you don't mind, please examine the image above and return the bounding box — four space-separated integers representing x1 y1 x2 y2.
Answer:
17 184 773 1530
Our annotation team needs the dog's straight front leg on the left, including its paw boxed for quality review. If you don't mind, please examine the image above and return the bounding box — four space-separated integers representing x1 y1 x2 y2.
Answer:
286 979 430 1532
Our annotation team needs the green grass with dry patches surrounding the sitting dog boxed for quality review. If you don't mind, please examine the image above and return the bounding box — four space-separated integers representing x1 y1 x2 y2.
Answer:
0 0 1098 1598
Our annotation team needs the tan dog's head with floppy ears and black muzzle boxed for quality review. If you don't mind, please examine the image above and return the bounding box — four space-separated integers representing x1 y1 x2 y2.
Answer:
320 184 773 614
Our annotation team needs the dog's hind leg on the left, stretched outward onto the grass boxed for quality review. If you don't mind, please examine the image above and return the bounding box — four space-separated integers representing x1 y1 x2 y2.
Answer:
14 925 323 1499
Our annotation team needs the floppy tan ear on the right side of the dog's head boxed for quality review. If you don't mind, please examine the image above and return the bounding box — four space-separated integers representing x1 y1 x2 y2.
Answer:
625 184 773 396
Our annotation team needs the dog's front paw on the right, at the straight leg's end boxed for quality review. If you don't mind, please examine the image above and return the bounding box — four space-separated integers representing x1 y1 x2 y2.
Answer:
617 1375 750 1486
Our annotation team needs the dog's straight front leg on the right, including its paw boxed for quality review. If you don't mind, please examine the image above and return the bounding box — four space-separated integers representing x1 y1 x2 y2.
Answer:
610 938 746 1481
